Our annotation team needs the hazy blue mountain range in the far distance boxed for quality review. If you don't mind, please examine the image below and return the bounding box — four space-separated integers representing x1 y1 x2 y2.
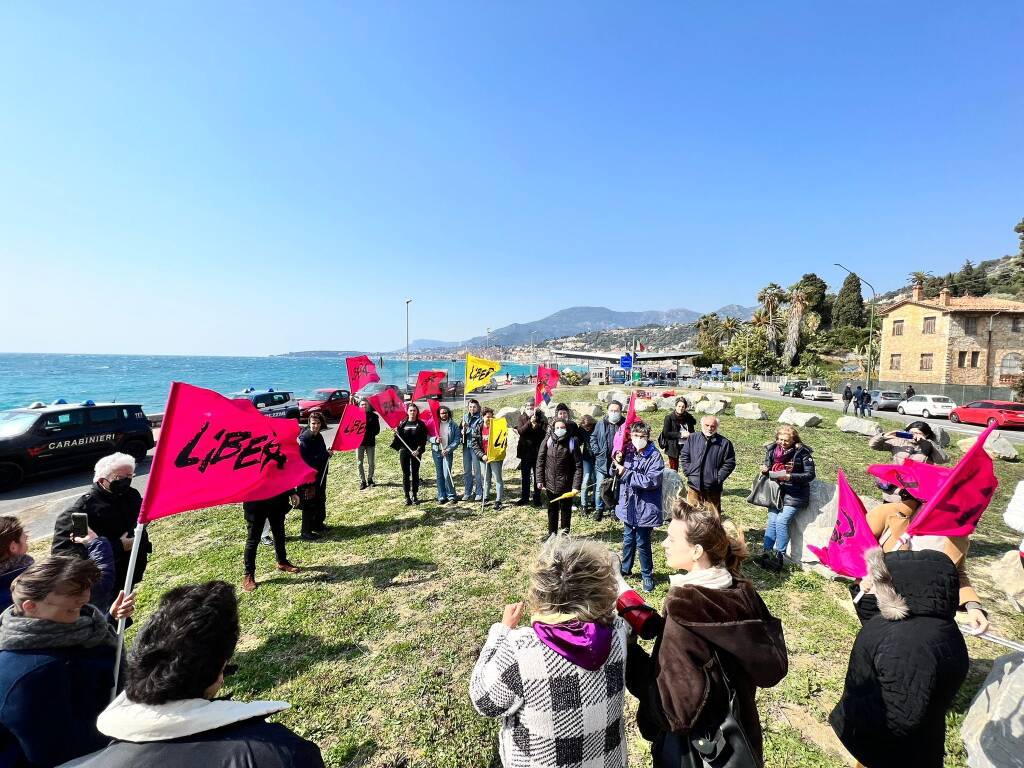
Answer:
410 304 757 351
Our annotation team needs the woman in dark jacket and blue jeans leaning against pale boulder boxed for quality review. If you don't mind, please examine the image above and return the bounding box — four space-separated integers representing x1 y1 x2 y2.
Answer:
754 425 814 573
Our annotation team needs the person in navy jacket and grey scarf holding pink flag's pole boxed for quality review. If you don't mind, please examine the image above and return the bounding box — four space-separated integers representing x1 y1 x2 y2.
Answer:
0 556 135 768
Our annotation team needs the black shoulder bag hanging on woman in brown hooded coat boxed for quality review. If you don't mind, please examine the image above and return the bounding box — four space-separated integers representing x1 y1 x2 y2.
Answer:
654 652 761 768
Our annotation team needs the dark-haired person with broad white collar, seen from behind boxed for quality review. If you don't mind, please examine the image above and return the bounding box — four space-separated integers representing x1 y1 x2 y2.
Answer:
68 582 324 768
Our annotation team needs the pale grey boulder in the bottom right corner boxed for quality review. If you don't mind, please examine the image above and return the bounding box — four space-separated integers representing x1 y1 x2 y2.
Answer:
961 652 1024 768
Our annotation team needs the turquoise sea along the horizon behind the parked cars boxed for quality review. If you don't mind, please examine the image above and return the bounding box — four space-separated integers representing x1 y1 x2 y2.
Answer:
0 353 583 413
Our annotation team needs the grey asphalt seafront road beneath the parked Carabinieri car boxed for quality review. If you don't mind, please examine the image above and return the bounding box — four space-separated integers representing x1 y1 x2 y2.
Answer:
0 384 534 541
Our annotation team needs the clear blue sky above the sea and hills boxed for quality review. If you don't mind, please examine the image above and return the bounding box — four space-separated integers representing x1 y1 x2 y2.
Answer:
0 0 1024 354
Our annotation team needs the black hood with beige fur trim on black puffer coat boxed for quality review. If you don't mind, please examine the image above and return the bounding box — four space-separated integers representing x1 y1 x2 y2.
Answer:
864 547 959 622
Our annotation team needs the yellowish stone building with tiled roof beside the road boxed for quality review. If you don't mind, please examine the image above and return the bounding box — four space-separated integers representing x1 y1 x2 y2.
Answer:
879 286 1024 396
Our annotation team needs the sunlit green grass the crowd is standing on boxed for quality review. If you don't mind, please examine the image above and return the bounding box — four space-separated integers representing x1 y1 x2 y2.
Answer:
32 388 1024 768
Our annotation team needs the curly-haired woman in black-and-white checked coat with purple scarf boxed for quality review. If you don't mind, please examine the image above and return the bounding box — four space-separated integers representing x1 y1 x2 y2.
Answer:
469 536 628 768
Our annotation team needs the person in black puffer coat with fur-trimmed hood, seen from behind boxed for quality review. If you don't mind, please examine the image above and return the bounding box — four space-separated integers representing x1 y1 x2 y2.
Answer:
828 549 970 768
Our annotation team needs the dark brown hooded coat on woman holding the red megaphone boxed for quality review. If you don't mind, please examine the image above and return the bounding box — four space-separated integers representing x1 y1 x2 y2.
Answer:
626 581 788 761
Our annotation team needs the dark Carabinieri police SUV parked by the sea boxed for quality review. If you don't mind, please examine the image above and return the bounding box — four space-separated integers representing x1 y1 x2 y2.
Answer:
0 399 154 490
